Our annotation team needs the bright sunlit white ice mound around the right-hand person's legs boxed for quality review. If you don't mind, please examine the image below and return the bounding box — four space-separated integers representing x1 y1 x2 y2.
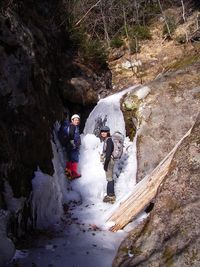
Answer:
72 134 136 228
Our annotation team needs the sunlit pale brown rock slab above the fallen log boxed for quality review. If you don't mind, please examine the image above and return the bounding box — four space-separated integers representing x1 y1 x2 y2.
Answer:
123 63 200 181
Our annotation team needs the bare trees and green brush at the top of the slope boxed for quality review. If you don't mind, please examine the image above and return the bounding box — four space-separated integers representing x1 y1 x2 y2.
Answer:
64 0 197 60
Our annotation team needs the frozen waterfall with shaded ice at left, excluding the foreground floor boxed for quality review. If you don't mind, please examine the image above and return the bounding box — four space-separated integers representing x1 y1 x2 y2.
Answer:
32 87 139 228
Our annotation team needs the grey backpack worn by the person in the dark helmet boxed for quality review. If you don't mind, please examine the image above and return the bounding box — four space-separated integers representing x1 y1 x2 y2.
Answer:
111 132 124 159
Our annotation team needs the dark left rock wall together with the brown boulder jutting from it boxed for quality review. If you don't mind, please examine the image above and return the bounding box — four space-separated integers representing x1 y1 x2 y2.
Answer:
0 0 111 248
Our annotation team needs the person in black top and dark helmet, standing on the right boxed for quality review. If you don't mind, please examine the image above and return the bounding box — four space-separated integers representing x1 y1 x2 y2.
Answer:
100 126 116 204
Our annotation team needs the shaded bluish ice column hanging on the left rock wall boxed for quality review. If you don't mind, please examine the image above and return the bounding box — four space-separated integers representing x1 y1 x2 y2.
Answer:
32 127 80 229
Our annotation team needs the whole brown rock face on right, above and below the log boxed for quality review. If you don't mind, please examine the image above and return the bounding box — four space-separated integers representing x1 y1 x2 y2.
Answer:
113 58 200 267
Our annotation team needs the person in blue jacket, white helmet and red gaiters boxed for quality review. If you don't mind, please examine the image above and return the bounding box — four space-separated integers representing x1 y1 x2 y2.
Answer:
65 114 81 179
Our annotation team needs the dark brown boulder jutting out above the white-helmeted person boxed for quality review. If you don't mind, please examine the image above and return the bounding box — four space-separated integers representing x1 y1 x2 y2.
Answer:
60 60 112 107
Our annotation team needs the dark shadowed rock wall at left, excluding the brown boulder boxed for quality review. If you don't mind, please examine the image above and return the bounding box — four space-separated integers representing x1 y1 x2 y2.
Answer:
0 2 62 203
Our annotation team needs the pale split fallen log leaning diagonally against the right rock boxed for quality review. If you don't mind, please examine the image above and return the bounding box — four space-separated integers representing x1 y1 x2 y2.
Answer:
107 129 191 232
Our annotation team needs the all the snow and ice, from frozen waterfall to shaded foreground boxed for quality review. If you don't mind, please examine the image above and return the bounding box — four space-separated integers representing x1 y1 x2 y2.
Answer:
7 88 148 267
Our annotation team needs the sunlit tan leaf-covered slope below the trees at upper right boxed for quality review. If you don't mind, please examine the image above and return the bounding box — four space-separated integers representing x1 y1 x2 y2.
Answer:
109 15 200 91
